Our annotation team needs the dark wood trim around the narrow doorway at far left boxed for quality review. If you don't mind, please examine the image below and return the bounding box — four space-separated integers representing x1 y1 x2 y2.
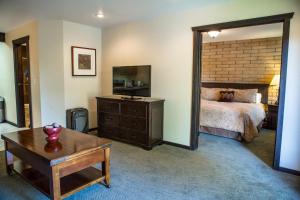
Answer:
12 36 33 128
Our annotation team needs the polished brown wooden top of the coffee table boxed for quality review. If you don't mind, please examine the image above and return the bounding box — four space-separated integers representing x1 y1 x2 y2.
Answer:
1 128 111 165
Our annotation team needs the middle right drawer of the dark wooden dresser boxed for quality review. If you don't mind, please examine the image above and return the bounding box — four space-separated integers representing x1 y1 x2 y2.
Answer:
120 116 147 131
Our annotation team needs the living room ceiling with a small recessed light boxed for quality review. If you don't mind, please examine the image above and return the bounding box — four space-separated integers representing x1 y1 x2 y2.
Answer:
0 0 228 32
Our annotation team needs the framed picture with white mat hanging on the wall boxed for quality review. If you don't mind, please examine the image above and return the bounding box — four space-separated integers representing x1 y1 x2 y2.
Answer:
71 46 97 76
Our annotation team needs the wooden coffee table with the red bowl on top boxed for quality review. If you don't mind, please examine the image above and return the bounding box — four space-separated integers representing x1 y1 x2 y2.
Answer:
1 128 111 200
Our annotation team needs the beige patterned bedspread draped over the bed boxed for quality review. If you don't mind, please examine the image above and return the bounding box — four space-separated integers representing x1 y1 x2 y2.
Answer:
200 99 265 140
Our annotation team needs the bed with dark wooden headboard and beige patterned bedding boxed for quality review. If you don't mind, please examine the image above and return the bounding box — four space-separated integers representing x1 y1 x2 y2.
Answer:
199 83 269 142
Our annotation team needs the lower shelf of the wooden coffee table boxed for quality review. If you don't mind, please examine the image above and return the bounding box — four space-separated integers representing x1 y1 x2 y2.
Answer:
13 161 105 199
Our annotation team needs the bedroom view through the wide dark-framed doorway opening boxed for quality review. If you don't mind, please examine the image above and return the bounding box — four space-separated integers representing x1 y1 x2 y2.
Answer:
199 23 282 167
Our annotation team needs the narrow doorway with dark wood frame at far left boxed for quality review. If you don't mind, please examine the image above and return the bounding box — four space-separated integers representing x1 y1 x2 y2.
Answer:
13 36 33 128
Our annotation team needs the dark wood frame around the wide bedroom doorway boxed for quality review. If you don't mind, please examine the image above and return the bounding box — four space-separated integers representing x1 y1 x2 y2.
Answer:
190 13 294 170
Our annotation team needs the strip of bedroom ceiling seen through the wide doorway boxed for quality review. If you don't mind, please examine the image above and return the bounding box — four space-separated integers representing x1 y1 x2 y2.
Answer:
203 23 282 43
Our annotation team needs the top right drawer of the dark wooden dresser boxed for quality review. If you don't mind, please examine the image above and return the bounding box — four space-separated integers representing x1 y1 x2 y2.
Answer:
121 103 147 117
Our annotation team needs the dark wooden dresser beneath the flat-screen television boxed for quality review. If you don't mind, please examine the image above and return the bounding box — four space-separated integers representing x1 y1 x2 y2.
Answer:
97 96 164 150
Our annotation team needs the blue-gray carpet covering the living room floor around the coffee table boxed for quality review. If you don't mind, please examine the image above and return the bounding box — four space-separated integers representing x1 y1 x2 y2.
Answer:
0 130 300 200
